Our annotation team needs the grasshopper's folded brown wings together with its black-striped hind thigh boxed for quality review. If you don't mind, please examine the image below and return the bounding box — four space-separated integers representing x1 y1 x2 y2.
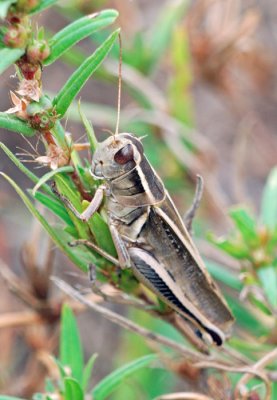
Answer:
130 195 234 344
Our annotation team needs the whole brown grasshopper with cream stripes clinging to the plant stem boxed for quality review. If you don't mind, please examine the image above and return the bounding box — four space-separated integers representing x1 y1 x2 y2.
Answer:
51 38 234 346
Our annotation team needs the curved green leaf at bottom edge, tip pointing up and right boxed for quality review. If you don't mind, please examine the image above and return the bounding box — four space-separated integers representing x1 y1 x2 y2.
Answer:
92 354 158 400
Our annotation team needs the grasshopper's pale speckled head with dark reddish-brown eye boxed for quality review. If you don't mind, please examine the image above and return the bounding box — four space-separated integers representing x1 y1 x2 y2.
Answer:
91 133 143 180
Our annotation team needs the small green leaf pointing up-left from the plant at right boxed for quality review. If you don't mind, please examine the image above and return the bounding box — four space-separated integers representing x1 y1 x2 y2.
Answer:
229 208 259 246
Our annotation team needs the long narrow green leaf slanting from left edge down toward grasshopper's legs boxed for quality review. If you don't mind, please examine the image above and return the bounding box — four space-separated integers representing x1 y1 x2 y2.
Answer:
0 172 87 272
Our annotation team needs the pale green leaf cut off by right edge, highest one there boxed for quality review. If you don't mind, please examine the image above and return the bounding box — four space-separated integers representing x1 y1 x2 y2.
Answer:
261 167 277 229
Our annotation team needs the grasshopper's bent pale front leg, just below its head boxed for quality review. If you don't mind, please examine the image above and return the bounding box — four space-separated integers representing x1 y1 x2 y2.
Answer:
52 183 106 221
